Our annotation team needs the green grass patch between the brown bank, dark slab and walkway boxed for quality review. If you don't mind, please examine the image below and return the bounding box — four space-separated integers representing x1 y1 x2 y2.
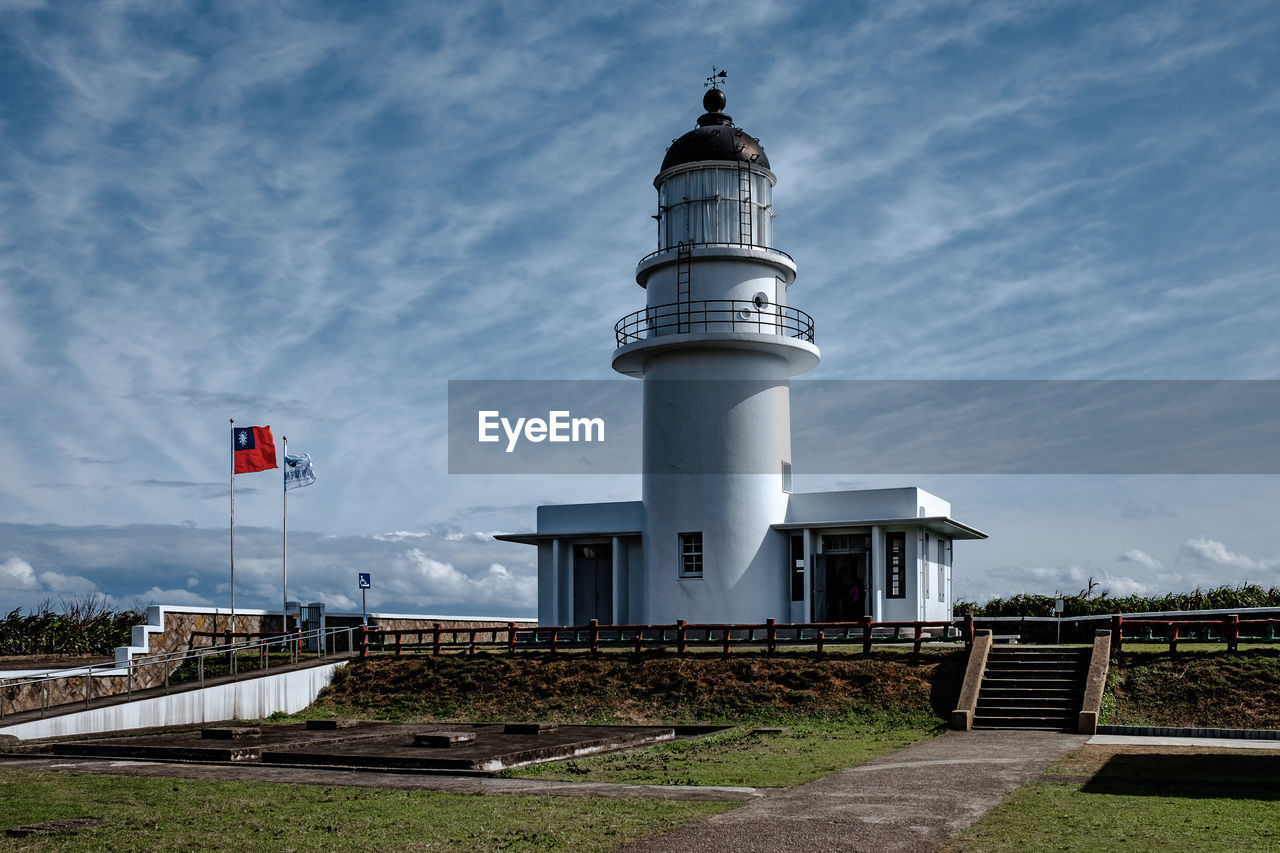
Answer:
507 715 942 788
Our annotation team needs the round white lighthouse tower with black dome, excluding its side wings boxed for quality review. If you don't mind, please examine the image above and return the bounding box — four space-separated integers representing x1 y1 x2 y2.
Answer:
613 86 819 622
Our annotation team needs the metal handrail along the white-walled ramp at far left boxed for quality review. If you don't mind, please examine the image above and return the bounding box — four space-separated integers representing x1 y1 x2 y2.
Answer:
0 617 357 720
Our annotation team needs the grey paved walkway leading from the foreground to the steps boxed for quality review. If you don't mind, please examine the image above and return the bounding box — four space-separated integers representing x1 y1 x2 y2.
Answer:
622 731 1088 853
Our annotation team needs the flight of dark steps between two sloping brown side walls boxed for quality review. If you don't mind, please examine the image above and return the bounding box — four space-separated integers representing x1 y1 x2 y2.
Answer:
973 646 1091 731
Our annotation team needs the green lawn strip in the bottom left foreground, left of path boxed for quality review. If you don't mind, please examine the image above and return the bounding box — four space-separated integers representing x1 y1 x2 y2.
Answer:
0 767 735 853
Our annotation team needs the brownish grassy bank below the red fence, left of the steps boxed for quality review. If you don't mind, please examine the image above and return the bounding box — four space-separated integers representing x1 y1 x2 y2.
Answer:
312 651 965 724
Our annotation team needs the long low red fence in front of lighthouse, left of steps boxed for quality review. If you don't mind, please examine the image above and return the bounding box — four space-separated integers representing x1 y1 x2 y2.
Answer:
360 619 973 657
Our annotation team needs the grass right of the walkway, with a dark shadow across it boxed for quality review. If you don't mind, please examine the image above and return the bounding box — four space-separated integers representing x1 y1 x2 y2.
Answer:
943 747 1280 853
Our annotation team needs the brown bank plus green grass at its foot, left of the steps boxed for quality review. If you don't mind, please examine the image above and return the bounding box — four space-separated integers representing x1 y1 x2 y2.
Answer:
308 651 965 786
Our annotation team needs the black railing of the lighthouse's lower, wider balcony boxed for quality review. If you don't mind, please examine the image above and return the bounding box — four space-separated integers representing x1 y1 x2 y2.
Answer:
613 300 813 347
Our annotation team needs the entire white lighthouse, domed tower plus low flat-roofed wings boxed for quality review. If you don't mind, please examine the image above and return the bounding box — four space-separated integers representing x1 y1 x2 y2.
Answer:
498 88 986 625
